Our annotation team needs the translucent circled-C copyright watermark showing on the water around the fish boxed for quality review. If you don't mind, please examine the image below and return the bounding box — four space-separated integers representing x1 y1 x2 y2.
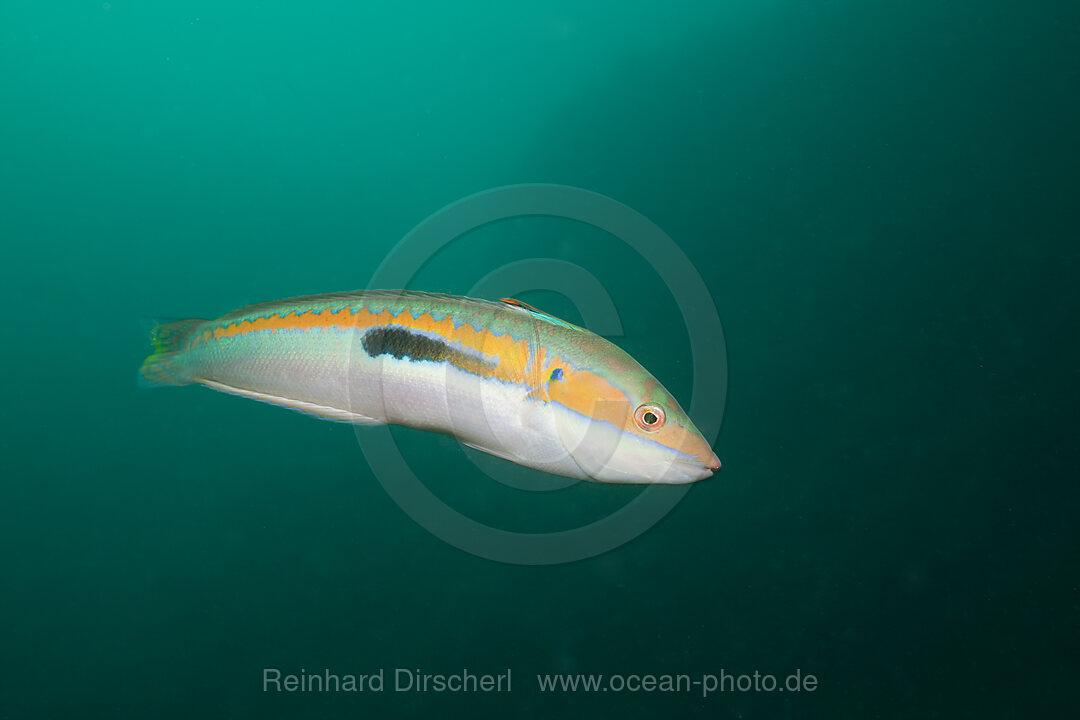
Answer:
356 185 728 565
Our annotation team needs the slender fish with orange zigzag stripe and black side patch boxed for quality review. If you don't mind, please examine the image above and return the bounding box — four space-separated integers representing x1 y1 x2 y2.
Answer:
139 290 720 484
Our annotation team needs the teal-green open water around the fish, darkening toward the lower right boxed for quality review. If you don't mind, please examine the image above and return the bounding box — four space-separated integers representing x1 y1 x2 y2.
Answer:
0 0 1080 718
